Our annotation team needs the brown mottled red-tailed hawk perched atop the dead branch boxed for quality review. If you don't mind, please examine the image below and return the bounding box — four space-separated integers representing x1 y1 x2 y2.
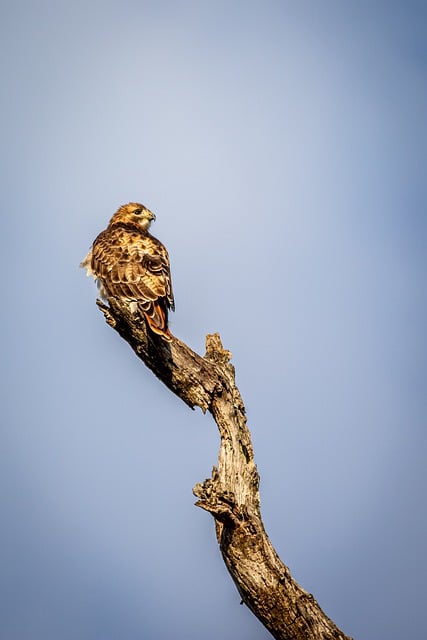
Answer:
80 202 175 341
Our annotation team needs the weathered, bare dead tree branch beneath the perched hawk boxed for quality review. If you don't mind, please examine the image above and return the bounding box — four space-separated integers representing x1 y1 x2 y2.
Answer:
97 299 350 640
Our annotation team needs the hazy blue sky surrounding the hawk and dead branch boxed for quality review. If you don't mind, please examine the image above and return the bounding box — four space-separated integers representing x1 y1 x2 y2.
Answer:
0 0 427 640
